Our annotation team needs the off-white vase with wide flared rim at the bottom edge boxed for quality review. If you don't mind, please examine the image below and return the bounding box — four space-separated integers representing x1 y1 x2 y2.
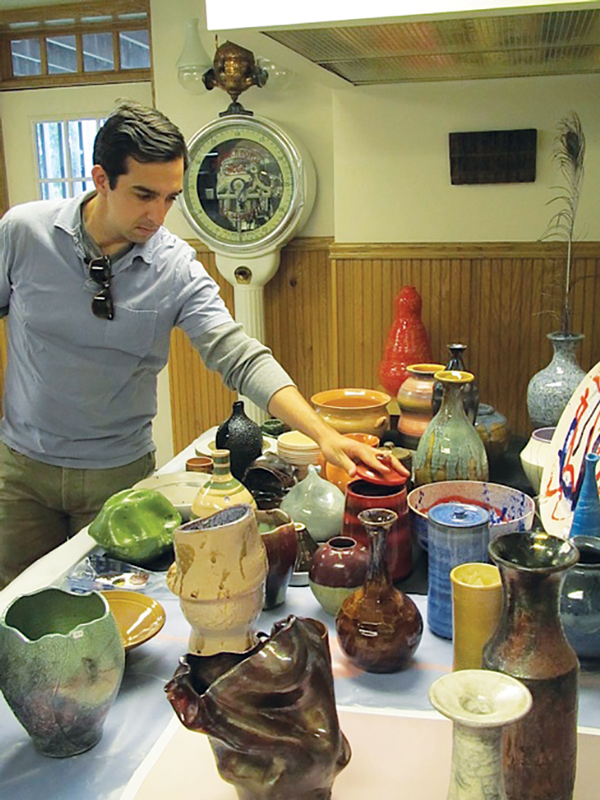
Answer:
429 669 532 800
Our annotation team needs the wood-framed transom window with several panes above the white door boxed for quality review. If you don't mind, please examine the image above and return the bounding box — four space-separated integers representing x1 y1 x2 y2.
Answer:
0 0 151 90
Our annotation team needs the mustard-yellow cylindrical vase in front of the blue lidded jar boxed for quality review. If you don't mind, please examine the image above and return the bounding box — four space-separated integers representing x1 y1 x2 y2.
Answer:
450 562 502 670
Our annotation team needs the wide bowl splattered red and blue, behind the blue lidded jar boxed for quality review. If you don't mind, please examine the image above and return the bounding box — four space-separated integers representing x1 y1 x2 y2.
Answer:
408 481 535 549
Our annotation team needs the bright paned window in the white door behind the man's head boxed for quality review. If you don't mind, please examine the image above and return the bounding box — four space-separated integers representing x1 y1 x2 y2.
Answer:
35 118 104 200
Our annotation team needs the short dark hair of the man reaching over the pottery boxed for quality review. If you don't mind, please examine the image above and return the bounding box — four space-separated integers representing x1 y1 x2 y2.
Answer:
94 100 188 189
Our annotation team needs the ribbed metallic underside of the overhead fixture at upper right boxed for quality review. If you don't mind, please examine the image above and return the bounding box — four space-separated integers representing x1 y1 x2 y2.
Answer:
263 7 600 86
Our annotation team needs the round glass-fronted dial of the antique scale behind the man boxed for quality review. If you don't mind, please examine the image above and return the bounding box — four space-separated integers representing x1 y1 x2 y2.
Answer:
182 115 304 254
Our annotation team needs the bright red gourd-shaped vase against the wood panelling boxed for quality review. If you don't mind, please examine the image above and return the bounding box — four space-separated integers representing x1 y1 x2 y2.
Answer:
379 286 431 397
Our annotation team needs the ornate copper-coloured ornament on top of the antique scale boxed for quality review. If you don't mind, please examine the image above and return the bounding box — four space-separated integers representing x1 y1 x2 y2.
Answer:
202 42 269 117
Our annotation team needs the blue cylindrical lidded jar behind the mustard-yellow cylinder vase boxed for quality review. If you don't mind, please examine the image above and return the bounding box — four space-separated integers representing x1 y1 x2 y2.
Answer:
427 503 490 639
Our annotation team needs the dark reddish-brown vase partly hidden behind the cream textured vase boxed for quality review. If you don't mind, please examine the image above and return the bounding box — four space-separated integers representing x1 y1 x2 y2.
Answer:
255 508 298 609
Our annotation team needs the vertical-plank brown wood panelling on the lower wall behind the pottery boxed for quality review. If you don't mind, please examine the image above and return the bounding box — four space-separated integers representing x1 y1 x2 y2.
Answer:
171 239 600 450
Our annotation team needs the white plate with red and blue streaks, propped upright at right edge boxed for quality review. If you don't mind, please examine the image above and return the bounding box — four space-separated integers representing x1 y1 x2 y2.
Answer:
539 362 600 538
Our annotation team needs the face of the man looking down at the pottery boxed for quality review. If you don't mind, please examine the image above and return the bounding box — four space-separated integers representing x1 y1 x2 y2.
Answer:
92 157 184 245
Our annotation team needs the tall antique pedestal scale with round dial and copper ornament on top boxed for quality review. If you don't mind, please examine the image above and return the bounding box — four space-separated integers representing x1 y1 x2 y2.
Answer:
181 42 316 419
